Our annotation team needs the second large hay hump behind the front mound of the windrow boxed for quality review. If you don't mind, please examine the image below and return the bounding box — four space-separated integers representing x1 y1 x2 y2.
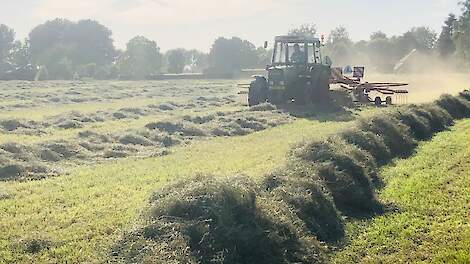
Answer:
294 138 381 213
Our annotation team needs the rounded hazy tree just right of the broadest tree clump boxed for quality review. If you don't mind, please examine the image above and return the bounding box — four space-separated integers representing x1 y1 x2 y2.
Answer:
119 36 161 80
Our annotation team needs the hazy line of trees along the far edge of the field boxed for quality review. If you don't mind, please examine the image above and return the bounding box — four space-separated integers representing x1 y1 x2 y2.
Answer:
0 0 470 80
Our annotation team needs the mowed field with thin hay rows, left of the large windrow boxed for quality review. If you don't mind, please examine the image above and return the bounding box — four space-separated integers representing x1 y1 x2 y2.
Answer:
0 75 470 263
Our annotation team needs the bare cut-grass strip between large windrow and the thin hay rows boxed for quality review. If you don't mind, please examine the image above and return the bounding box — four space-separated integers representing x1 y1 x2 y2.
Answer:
0 120 350 263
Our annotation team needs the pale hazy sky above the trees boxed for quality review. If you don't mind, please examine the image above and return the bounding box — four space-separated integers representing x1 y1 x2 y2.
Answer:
0 0 460 51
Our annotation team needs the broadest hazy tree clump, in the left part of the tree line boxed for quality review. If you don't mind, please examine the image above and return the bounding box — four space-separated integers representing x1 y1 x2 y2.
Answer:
29 19 115 79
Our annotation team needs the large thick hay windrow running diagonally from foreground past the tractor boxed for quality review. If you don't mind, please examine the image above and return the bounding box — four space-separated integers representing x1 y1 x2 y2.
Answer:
108 93 470 263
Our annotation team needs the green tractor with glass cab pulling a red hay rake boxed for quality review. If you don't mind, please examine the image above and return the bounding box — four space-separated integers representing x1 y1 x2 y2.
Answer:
248 36 331 106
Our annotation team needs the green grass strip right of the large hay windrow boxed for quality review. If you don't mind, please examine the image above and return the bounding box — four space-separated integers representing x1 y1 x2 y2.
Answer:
332 119 470 263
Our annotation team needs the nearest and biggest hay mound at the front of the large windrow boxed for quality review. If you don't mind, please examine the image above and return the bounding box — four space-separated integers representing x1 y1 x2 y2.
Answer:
113 177 324 263
